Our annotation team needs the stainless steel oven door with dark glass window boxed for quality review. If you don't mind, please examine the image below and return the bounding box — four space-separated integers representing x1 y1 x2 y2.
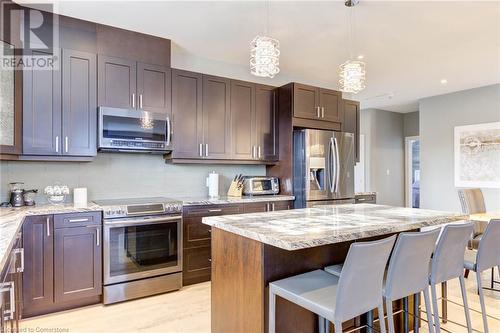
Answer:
103 216 182 285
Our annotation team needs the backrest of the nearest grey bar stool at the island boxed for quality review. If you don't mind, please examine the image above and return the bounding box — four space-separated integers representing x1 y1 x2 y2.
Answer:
334 235 396 322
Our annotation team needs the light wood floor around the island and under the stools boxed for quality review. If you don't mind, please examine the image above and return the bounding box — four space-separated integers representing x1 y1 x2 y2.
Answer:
21 272 500 333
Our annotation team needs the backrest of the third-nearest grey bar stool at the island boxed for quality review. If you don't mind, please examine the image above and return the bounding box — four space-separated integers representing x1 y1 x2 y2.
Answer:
430 223 473 284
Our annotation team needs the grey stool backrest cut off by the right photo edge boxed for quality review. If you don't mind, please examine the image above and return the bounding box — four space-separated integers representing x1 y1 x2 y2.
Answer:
476 220 500 272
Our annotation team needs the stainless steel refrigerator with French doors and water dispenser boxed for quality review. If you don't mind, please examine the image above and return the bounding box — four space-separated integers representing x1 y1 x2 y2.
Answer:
293 129 355 208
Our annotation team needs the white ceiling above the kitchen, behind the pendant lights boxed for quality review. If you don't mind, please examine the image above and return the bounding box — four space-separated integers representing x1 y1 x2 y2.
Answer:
19 0 500 112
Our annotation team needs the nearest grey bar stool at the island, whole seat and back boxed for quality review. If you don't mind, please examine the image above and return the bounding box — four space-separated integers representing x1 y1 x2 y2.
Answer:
269 236 396 333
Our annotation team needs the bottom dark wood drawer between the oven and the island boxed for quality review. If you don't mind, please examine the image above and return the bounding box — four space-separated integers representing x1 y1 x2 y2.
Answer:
182 246 212 285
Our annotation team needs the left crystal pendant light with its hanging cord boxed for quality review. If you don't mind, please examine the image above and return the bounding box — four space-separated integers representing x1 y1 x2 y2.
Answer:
250 0 280 78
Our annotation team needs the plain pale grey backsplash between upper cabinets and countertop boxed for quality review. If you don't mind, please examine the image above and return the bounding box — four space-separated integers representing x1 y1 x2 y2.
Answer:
0 153 266 203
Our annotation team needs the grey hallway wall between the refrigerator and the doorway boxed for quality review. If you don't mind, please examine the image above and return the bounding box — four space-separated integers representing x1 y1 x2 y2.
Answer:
360 109 404 206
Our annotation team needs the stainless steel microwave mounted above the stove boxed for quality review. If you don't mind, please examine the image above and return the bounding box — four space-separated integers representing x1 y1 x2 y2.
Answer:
98 107 172 154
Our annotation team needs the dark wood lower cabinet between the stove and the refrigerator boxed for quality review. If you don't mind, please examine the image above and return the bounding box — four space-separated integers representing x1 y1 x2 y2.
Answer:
182 201 292 286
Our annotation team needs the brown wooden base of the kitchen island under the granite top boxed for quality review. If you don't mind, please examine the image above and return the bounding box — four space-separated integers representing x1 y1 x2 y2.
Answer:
211 227 418 333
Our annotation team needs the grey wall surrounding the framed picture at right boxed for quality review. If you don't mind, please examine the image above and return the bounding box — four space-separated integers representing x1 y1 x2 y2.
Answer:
420 84 500 211
